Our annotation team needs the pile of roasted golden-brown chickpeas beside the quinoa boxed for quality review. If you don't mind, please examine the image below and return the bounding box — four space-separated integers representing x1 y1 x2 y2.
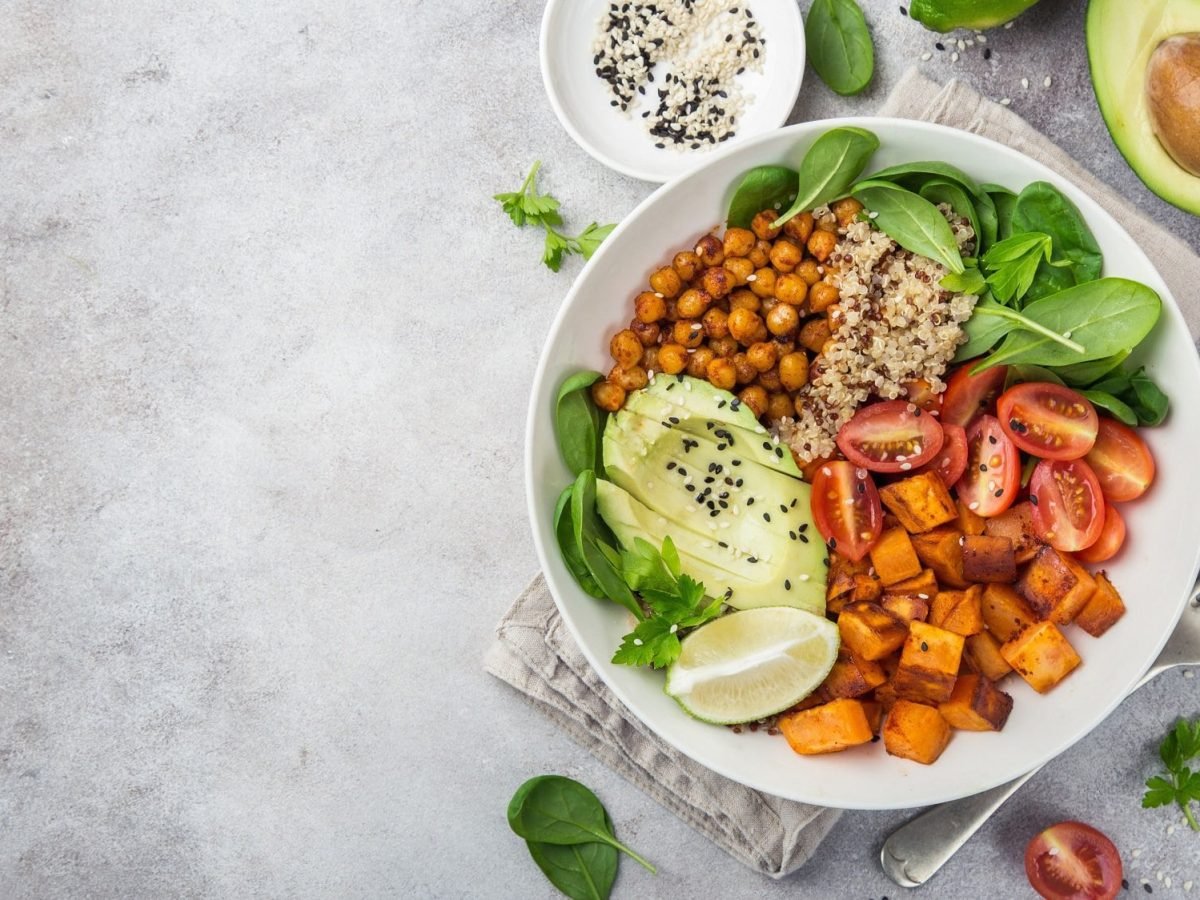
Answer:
592 198 863 421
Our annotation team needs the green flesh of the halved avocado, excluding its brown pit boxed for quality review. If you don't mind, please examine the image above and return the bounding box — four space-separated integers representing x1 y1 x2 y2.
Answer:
1087 0 1200 215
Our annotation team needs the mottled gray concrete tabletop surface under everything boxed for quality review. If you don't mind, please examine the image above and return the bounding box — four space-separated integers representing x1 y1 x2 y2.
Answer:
0 0 1200 899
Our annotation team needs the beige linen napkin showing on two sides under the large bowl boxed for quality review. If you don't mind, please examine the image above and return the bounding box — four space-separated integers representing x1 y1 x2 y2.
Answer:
485 71 1200 878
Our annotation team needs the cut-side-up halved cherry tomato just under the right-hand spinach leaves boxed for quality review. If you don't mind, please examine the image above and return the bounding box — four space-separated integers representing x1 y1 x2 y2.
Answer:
996 382 1099 460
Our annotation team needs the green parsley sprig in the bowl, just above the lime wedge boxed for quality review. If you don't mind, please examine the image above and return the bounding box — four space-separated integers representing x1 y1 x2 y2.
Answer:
612 538 724 668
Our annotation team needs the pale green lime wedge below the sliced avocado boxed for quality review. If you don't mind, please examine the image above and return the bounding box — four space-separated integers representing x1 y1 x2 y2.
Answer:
666 606 841 725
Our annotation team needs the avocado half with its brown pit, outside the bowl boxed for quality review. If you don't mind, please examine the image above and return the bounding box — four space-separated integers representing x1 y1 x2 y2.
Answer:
1087 0 1200 215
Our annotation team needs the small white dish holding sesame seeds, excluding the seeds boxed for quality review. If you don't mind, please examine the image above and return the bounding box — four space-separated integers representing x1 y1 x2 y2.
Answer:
541 0 804 182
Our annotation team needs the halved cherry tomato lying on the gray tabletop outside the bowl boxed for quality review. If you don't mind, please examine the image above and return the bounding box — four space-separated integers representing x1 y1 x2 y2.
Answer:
1025 822 1124 900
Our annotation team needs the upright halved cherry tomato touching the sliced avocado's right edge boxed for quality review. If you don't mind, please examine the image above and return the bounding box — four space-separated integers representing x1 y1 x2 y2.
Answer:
812 460 883 562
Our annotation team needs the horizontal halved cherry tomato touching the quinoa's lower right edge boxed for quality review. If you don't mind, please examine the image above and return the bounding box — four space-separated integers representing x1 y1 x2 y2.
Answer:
838 400 944 472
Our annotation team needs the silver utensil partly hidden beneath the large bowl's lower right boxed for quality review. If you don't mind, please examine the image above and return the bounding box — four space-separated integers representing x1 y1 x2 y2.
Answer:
880 582 1200 888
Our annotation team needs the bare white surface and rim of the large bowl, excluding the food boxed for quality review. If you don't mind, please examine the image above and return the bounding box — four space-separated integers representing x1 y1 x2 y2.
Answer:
526 119 1200 809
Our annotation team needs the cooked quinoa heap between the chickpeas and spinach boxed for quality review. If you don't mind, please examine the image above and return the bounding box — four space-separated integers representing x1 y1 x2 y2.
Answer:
775 204 978 462
